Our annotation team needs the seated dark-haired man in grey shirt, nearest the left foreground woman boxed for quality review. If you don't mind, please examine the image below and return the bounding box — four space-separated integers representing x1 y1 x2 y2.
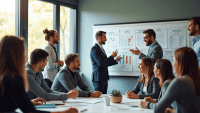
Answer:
26 49 78 101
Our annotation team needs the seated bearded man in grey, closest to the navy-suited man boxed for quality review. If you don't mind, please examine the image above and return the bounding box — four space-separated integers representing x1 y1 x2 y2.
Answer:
51 54 101 97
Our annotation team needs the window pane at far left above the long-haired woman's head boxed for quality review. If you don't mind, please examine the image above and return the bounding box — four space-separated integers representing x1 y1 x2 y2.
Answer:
0 0 15 39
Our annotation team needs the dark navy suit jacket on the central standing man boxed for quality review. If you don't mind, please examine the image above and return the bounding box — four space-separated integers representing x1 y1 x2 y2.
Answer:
90 43 117 81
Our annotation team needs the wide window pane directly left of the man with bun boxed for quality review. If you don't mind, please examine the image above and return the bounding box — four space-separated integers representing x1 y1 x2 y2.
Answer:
28 0 53 62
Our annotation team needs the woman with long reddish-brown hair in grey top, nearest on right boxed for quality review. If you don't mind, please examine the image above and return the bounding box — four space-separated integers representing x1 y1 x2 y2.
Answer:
149 47 200 113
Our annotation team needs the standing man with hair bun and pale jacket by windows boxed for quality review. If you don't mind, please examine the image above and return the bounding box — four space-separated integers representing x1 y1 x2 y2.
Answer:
43 29 64 88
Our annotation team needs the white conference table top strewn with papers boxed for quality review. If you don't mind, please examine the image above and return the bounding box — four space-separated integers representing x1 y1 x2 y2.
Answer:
30 94 153 113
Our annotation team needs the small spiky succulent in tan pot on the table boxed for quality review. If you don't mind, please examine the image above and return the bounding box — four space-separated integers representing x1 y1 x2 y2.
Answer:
110 89 122 103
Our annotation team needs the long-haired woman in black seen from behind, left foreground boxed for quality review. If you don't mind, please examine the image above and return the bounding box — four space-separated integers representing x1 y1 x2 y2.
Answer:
0 36 78 113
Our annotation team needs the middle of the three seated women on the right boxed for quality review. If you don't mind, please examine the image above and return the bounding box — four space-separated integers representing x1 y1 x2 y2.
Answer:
140 59 175 109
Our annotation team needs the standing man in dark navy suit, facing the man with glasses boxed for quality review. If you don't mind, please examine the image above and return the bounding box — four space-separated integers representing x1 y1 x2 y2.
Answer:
90 31 122 94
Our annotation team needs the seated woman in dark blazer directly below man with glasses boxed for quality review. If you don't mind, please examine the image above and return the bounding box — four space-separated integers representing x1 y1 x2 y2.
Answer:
126 58 160 99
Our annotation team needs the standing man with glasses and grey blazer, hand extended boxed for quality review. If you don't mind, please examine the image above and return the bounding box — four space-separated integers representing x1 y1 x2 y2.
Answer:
130 29 163 65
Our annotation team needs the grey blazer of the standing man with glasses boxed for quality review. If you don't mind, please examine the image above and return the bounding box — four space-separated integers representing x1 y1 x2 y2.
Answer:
139 41 163 65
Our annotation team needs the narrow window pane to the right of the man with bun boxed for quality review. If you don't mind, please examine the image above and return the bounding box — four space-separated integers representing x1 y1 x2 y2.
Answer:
60 6 76 61
